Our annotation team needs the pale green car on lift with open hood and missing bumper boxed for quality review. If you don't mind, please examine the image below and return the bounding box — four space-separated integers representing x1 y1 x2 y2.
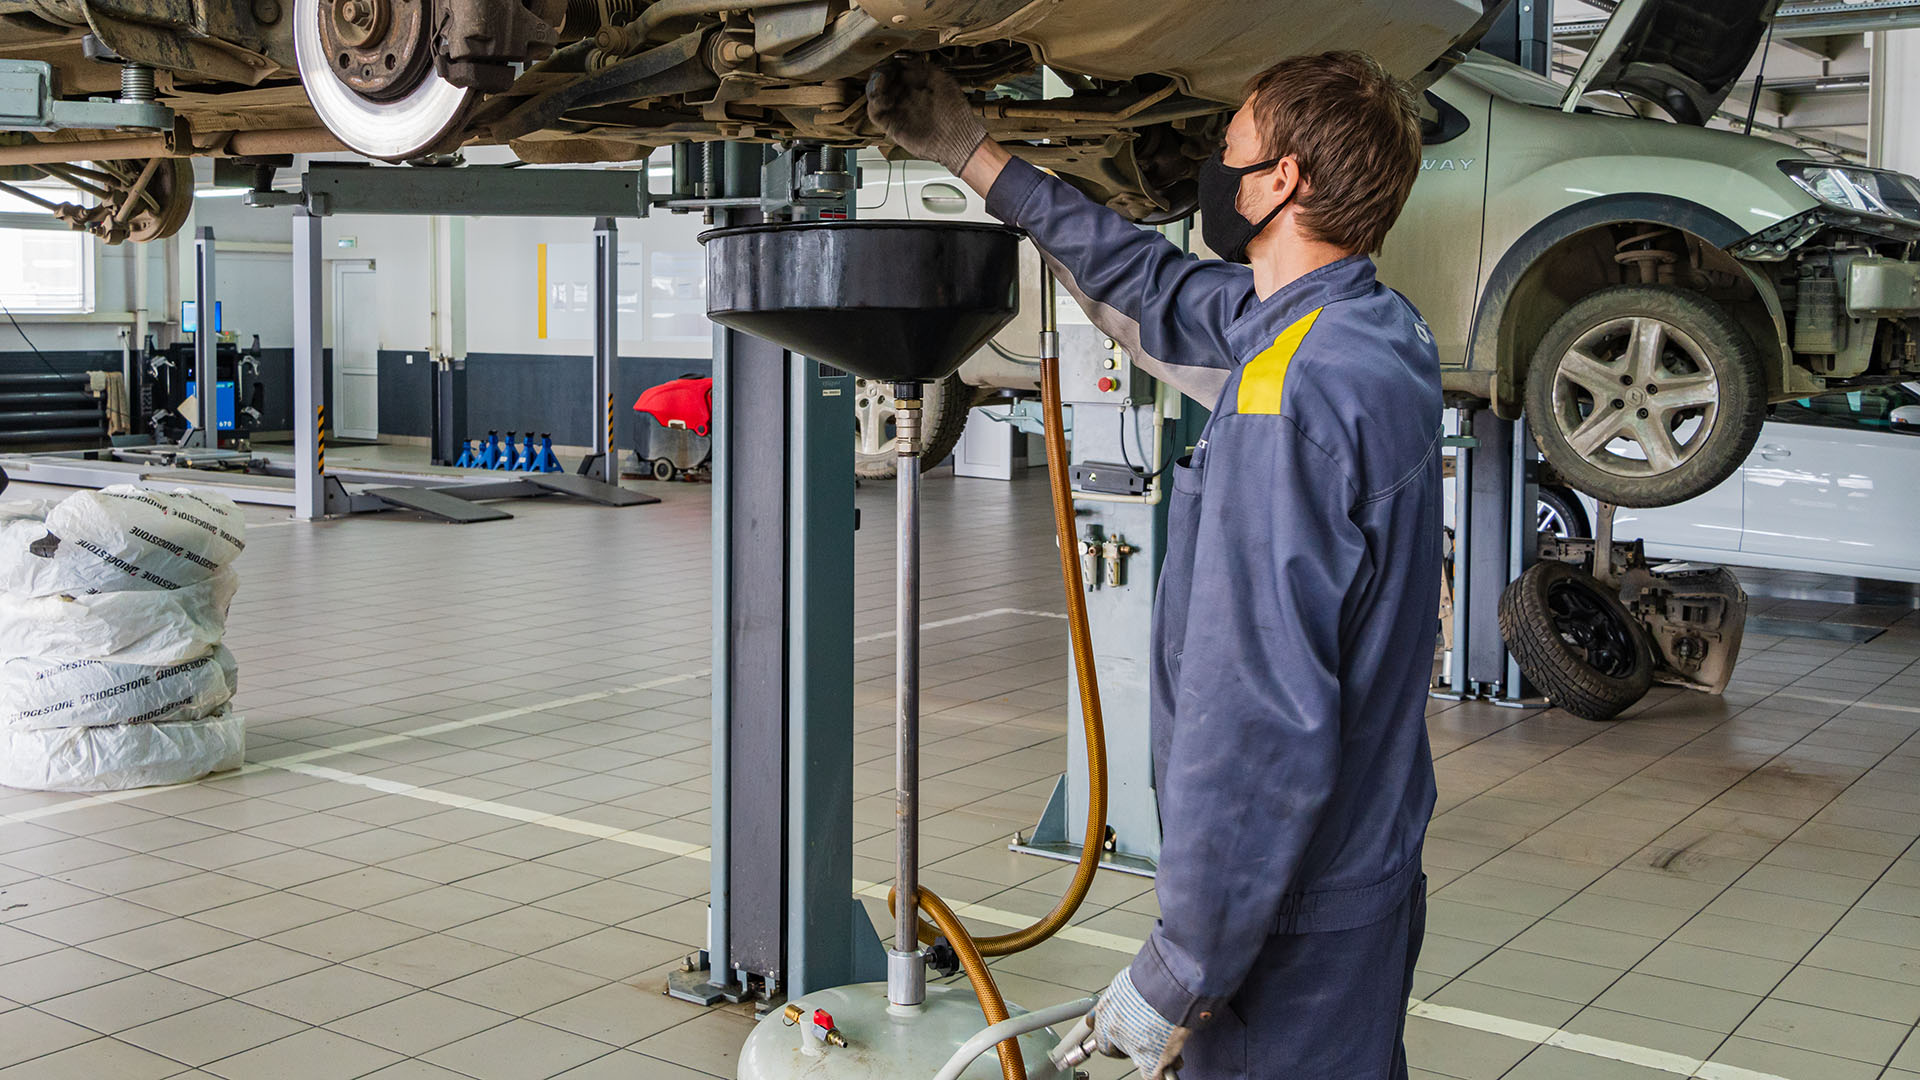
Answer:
1380 0 1920 507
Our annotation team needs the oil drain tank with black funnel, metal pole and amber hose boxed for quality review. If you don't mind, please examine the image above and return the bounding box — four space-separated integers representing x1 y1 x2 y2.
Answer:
701 221 1106 1080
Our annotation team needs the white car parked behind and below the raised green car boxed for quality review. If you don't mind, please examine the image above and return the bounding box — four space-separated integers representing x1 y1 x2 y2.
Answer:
1612 382 1920 582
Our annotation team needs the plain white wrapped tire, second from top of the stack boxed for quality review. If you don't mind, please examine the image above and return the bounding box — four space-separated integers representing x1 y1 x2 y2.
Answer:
0 569 238 667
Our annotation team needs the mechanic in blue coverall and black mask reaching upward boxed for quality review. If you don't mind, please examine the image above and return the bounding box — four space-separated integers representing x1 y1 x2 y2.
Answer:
868 54 1442 1080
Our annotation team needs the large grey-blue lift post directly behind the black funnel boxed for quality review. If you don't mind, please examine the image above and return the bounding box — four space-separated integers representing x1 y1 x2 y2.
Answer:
660 142 887 1005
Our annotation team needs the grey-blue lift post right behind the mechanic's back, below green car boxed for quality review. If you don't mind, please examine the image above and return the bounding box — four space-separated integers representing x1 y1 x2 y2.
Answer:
1434 407 1540 707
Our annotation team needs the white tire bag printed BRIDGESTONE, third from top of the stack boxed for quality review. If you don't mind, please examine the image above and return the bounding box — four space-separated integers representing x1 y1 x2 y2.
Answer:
0 646 240 728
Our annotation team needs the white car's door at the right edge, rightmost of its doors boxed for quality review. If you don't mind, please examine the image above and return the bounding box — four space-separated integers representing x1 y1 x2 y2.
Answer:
1741 386 1920 577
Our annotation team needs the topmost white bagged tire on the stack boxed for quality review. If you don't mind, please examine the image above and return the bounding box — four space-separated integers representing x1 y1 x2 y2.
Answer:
28 484 246 596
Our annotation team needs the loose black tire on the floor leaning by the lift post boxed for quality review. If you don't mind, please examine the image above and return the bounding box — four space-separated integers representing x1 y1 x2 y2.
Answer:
1500 561 1653 721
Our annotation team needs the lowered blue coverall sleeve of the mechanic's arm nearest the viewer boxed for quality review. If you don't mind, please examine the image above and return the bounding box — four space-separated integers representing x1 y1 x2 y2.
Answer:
1131 413 1367 1028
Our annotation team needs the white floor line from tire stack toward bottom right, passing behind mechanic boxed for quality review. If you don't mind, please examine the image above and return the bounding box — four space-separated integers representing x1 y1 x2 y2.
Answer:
255 763 1788 1080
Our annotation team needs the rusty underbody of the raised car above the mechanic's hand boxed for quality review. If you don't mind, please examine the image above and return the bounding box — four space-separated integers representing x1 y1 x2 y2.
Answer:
0 0 1482 228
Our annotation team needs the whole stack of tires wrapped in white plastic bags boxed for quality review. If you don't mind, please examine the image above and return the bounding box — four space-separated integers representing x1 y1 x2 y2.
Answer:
0 486 246 792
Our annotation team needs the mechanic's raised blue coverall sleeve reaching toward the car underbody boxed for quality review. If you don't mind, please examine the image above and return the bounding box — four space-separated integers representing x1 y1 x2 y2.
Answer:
987 160 1254 405
